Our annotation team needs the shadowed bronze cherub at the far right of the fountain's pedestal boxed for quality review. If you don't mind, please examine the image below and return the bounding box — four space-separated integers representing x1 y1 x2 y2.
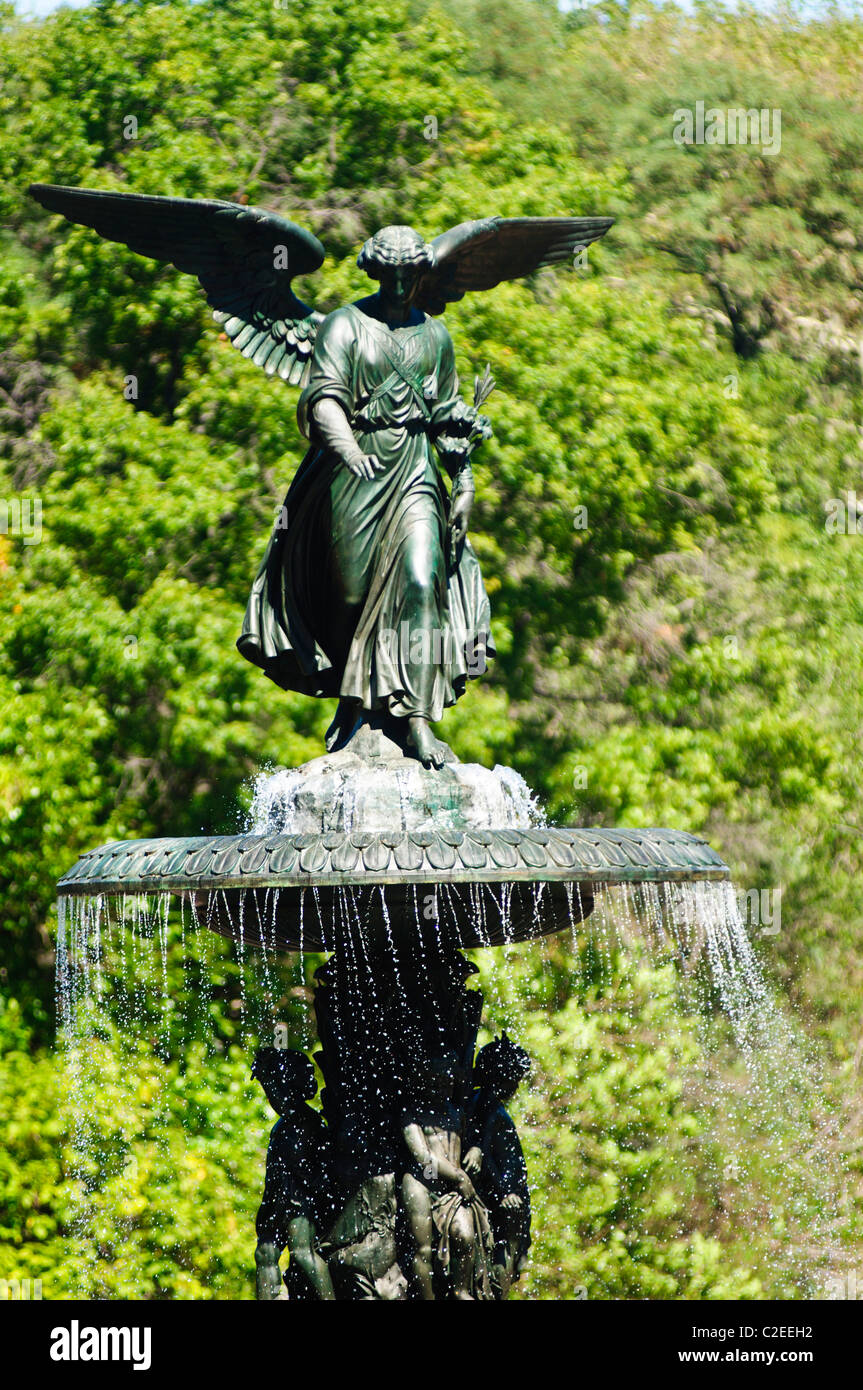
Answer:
464 1033 531 1298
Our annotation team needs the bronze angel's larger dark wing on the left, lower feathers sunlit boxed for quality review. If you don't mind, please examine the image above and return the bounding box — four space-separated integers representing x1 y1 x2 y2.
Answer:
29 183 324 385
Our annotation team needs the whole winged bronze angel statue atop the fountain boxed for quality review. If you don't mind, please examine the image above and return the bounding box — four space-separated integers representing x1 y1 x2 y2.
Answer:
31 183 611 767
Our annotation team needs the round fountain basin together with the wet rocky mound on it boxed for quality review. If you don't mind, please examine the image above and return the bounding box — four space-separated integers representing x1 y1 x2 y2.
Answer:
58 724 730 952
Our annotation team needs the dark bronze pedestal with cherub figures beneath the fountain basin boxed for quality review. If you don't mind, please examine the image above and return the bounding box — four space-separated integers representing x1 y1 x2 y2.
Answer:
253 940 531 1301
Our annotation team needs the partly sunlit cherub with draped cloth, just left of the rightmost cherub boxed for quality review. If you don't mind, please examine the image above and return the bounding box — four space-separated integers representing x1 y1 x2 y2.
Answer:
402 1054 492 1300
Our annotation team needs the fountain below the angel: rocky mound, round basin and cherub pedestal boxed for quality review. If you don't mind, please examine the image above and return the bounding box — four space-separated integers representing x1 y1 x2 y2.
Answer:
58 724 728 1298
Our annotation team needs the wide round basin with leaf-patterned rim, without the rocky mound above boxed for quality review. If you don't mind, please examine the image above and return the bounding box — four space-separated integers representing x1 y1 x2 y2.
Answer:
58 826 730 951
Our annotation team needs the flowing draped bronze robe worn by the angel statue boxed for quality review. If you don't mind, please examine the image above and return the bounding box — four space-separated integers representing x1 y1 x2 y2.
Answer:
238 304 493 720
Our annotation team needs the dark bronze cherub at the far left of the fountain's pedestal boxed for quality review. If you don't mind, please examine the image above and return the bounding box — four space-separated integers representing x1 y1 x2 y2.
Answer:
252 1047 335 1301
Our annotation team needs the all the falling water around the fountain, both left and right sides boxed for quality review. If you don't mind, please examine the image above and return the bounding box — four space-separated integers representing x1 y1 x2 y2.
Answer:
57 811 839 1297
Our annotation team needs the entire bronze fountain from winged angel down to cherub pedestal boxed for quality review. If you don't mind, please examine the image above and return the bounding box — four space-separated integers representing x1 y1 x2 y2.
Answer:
33 176 761 1300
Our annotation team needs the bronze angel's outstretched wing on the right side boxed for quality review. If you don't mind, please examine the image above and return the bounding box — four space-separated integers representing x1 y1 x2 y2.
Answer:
416 217 614 314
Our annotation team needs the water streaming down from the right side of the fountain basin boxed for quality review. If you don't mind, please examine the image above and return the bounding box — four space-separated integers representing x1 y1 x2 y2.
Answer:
464 881 846 1297
